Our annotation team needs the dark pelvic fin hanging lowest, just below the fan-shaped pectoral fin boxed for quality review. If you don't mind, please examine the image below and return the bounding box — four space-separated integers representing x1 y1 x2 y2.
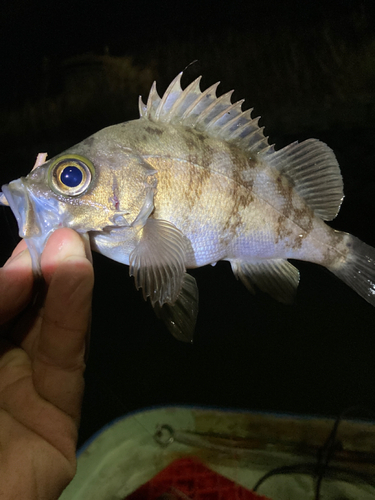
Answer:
154 273 198 342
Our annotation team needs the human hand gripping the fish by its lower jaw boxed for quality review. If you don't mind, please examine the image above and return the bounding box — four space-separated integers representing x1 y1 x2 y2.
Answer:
0 229 93 500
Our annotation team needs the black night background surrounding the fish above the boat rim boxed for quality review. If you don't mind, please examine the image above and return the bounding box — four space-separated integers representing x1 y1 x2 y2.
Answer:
0 0 375 443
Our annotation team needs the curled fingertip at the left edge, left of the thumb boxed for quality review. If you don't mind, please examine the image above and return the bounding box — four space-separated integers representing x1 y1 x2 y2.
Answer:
0 248 33 325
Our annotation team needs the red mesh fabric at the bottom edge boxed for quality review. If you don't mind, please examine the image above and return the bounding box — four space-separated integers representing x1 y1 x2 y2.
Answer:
126 458 270 500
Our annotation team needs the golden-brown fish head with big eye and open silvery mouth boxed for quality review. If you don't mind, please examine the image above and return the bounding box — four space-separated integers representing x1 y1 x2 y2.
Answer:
0 127 156 273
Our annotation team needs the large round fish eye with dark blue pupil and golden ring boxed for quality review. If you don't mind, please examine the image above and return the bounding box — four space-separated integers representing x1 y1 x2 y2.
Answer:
48 155 94 196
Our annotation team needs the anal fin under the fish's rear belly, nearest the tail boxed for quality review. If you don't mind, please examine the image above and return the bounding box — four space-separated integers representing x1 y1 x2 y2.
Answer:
231 259 299 304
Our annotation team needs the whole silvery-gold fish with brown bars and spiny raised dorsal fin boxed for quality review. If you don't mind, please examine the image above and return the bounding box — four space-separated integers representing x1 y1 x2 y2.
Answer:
0 72 375 342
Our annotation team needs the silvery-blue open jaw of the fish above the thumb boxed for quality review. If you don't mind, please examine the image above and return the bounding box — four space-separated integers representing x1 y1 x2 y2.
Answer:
2 177 66 275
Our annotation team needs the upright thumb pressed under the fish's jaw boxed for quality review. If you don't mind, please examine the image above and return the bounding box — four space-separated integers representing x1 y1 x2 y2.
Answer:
33 230 93 421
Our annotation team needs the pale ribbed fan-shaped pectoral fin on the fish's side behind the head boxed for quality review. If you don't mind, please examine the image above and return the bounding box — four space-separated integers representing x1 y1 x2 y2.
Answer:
129 218 185 306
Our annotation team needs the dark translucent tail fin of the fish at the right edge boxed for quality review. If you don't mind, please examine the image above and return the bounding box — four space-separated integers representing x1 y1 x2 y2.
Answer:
329 235 375 306
